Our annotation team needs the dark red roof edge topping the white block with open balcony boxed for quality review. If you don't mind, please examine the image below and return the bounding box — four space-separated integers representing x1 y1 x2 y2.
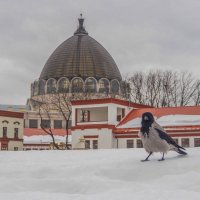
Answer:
72 98 151 108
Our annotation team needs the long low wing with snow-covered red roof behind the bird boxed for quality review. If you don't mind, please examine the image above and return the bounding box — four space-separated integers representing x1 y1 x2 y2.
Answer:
113 106 200 148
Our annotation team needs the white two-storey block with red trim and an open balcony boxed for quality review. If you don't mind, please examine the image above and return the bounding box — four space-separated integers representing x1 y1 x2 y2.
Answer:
71 98 149 149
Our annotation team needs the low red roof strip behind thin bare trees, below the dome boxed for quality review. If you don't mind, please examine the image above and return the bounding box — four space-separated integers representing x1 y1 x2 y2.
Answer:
24 128 71 136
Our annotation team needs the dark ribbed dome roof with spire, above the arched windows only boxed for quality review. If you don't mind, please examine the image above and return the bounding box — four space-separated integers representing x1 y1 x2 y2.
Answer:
40 18 122 81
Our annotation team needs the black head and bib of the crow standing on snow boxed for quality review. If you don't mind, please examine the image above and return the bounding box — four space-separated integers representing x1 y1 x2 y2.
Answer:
140 112 154 135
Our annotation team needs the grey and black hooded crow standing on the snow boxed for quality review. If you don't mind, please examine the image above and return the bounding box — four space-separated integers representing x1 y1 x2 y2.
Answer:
139 112 187 161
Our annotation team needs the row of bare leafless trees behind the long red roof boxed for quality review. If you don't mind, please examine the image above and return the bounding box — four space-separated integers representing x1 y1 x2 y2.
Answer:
126 70 200 107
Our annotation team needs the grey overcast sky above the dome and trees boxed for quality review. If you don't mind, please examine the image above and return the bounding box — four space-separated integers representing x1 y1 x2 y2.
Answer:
0 0 200 104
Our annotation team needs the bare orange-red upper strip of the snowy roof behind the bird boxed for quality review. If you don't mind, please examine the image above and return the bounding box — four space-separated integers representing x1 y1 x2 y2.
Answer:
118 106 200 125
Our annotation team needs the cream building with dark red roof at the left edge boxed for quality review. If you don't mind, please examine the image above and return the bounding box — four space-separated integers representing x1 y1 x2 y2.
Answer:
0 110 24 151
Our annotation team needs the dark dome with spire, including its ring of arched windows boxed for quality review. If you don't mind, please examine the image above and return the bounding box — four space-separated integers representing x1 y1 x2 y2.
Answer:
31 16 123 99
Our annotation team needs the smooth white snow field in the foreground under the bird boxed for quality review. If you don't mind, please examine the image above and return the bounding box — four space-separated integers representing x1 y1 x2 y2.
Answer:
0 148 200 200
